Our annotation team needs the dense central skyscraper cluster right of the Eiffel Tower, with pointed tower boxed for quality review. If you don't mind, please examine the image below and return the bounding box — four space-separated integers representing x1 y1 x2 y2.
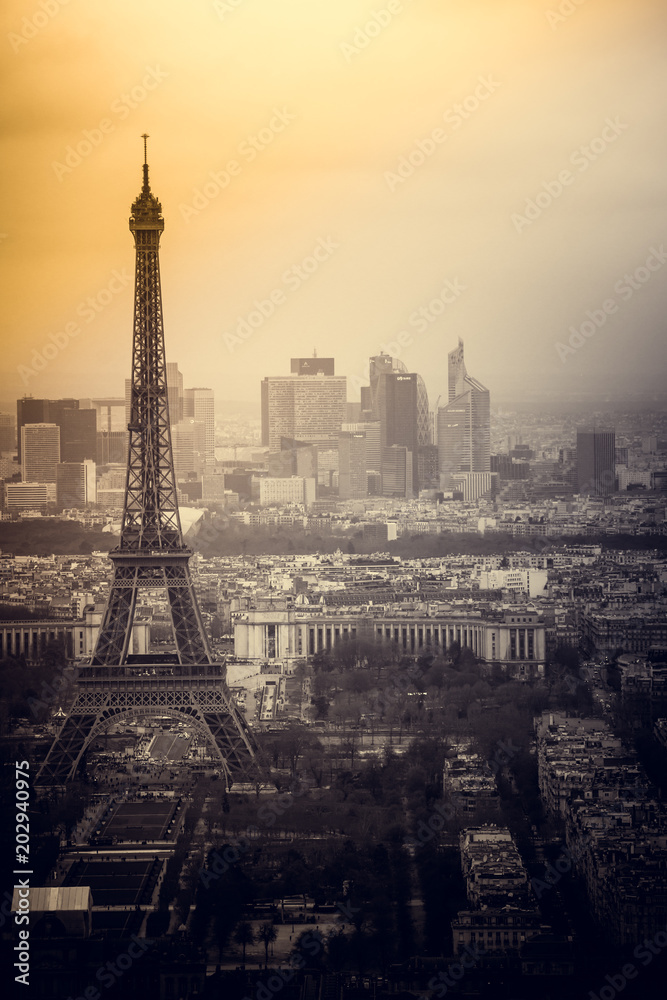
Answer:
262 341 491 499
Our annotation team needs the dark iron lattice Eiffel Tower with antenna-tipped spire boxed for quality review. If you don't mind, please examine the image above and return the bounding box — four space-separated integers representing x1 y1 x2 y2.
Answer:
37 135 260 786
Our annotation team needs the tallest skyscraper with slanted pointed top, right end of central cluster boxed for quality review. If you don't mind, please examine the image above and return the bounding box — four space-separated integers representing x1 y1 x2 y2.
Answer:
437 340 491 489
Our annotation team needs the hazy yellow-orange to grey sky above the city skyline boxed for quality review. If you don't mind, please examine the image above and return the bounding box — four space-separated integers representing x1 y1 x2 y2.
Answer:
0 0 667 414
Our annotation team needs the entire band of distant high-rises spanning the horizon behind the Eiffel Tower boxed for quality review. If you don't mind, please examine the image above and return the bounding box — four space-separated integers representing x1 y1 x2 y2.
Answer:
0 340 627 511
